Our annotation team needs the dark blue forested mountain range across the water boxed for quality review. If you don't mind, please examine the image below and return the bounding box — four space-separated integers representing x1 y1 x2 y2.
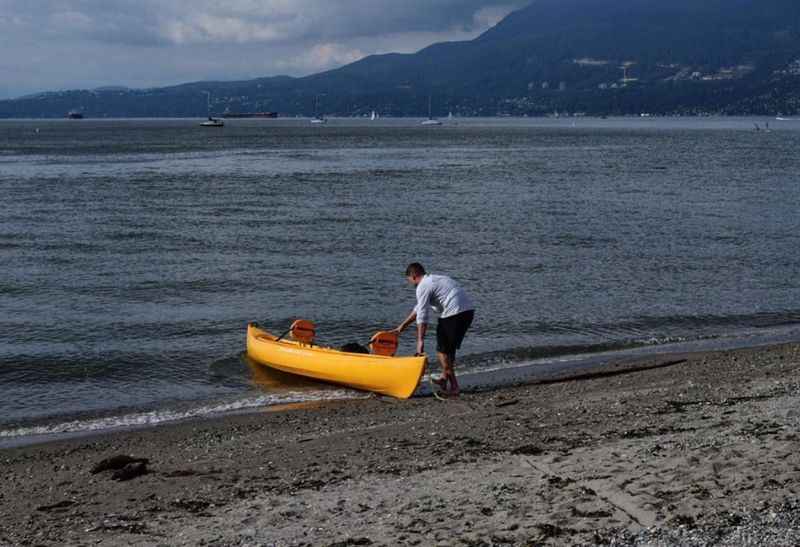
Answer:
0 0 800 117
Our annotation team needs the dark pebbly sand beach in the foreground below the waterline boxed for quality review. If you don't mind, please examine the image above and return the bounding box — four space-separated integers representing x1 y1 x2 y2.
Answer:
0 344 800 546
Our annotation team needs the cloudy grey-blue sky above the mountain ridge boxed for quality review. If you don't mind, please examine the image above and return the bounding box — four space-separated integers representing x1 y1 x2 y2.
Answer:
0 0 530 98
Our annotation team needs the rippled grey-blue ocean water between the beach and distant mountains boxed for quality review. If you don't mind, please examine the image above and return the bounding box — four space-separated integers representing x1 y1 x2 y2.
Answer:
0 118 800 444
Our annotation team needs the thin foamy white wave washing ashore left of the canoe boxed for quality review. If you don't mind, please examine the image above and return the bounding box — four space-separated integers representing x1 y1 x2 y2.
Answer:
0 390 365 439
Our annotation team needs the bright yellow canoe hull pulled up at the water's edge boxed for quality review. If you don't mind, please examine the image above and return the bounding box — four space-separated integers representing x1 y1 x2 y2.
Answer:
247 323 426 399
